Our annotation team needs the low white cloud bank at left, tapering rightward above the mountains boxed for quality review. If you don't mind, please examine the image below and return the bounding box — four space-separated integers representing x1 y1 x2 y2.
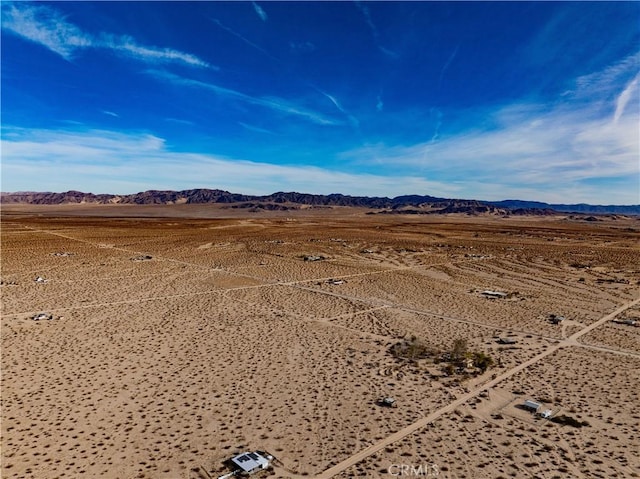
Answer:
1 128 460 196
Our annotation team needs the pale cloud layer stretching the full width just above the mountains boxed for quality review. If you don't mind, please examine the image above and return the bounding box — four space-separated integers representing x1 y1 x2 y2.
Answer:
0 120 638 204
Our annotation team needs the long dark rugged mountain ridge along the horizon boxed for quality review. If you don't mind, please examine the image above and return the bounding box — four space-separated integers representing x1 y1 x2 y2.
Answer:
0 188 640 215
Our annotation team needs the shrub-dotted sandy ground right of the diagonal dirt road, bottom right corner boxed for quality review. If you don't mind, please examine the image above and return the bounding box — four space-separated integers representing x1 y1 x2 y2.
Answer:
337 348 640 479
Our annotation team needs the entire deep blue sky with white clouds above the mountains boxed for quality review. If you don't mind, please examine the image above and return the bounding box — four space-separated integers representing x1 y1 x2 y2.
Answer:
1 1 640 204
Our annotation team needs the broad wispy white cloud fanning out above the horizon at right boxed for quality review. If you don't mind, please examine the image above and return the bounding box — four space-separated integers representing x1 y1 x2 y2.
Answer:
343 109 640 203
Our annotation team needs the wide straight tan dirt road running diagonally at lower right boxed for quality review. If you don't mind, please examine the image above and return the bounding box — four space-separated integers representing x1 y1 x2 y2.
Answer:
316 298 640 479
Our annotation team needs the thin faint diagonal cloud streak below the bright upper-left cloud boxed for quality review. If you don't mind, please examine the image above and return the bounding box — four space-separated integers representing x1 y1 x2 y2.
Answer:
148 70 343 125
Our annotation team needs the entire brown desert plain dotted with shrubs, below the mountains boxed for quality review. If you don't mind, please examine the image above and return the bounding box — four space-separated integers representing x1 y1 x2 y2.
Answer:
0 205 640 479
